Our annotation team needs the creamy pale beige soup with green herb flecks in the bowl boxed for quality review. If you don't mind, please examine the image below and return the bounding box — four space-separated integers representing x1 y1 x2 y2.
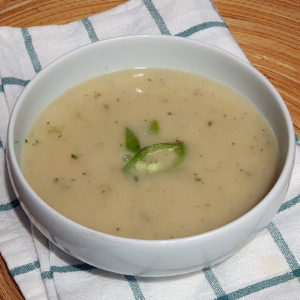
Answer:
23 68 278 239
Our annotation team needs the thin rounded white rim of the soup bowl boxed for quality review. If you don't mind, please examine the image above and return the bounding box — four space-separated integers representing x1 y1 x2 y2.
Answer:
6 34 295 246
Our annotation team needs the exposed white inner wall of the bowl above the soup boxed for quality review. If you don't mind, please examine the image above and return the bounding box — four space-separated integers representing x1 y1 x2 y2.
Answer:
11 36 290 190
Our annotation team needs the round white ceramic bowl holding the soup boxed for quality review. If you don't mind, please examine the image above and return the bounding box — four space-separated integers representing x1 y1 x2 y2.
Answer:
7 36 295 276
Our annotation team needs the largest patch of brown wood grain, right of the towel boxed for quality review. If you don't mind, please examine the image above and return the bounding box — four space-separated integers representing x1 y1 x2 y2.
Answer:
215 0 300 135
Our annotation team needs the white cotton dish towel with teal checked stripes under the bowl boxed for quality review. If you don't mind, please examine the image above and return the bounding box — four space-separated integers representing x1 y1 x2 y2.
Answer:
0 0 300 300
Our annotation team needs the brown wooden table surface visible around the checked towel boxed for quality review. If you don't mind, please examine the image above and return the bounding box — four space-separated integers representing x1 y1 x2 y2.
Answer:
0 0 300 300
